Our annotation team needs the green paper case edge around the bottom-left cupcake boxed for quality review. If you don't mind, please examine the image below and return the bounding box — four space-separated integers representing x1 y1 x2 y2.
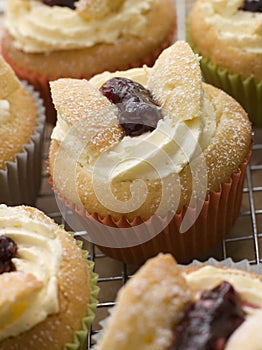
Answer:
64 241 99 350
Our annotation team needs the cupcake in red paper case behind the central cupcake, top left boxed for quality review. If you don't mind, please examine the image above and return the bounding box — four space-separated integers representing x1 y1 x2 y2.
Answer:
2 0 175 123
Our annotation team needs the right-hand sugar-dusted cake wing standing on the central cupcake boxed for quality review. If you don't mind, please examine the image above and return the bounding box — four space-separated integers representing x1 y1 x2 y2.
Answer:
147 41 202 124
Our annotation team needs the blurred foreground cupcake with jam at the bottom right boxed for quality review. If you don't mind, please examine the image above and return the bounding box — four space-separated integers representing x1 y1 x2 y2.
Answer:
95 255 262 350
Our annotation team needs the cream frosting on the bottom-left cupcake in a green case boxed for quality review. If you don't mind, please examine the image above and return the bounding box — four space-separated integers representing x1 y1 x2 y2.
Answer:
0 205 62 340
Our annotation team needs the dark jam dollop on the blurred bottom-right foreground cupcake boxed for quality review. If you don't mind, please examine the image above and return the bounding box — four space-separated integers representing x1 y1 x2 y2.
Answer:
169 281 245 350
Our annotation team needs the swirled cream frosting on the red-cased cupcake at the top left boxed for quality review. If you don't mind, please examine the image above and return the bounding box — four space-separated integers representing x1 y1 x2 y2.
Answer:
6 0 158 53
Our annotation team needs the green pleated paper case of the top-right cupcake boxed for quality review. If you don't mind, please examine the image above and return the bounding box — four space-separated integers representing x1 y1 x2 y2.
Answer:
190 47 262 128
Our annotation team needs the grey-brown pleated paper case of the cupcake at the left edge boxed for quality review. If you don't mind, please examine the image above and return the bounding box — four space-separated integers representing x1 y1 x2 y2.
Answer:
0 82 45 205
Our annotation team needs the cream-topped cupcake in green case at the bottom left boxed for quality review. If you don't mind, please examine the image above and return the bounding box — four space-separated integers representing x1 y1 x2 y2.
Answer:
0 205 97 350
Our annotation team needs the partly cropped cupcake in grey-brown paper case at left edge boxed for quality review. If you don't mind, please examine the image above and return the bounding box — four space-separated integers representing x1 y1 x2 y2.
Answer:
0 56 45 205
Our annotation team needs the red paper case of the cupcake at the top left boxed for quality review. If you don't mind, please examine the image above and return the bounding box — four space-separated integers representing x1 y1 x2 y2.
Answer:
2 29 175 125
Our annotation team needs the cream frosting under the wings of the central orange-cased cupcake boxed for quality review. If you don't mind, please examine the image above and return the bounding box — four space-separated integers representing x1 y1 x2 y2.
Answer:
51 66 216 181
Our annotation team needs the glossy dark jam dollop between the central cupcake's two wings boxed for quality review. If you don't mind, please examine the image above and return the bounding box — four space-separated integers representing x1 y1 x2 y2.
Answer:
100 77 163 136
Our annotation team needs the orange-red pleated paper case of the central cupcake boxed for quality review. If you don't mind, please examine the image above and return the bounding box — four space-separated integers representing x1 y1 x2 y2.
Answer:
50 146 251 265
